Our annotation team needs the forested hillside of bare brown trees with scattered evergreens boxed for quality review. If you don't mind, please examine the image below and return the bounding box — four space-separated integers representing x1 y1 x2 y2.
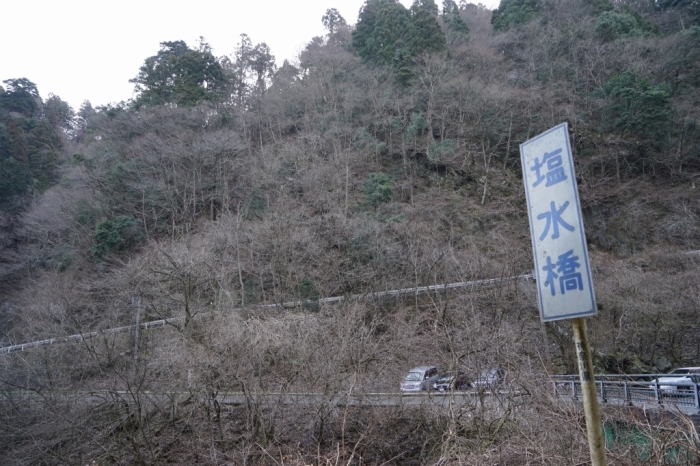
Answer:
0 0 700 465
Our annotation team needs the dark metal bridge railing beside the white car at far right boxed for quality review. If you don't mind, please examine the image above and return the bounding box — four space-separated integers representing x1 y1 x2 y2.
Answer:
552 374 700 410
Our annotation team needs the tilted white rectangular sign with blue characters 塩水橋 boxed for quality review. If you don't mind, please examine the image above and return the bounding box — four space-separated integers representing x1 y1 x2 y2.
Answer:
520 123 597 322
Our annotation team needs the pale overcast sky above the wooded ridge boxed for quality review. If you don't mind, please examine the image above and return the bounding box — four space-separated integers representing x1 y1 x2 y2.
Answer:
0 0 499 110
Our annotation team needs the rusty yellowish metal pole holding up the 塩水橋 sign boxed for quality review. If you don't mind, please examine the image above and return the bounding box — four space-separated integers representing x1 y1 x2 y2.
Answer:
573 317 608 466
